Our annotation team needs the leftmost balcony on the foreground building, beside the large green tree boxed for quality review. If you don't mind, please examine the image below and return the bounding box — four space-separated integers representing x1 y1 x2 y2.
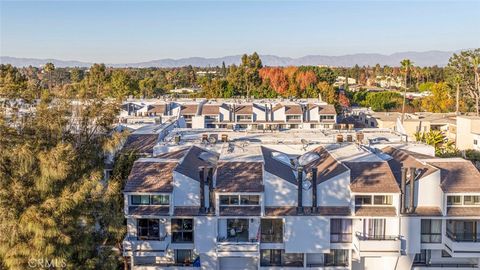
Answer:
122 235 170 256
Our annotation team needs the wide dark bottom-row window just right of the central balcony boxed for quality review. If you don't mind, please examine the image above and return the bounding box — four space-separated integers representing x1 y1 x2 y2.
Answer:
260 249 303 267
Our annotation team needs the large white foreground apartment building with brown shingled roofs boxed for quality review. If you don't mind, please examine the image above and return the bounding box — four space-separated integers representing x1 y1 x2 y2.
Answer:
123 130 480 270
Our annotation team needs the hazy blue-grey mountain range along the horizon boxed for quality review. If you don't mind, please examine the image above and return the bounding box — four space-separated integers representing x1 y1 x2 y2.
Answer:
0 51 464 67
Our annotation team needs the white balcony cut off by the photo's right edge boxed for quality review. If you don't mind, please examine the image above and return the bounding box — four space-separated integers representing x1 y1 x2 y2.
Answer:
444 230 480 257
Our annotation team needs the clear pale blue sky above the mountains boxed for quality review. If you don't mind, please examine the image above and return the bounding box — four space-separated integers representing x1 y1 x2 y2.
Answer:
0 0 480 63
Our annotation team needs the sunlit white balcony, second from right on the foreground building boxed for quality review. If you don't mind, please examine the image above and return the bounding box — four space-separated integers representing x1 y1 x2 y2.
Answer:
354 233 401 257
